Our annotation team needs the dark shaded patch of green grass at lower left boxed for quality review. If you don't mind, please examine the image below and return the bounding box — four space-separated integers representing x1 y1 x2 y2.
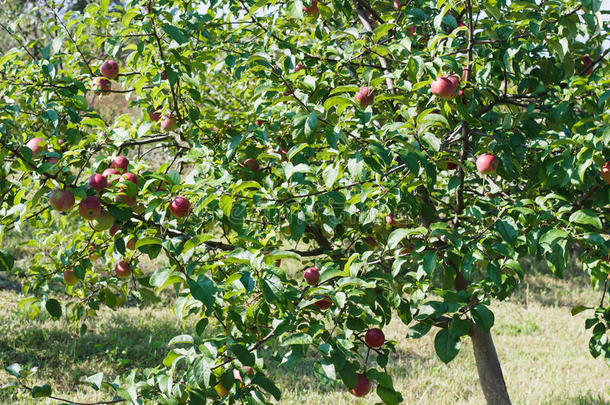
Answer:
0 315 181 388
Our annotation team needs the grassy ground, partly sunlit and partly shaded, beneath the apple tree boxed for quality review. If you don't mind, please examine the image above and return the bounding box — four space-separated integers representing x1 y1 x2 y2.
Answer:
0 275 610 405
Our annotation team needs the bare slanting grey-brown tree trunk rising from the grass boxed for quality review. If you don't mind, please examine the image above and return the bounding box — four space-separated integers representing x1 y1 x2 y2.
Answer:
470 324 511 405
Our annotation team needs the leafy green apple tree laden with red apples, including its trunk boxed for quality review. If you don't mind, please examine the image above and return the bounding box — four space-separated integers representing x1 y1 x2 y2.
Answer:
0 0 610 404
